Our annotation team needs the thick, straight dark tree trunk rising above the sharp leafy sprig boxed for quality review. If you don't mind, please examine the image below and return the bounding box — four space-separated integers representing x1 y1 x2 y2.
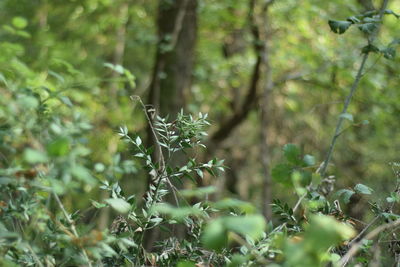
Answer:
149 0 197 117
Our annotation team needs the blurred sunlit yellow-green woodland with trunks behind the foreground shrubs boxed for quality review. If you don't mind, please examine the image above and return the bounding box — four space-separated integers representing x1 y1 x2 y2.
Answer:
0 0 400 228
